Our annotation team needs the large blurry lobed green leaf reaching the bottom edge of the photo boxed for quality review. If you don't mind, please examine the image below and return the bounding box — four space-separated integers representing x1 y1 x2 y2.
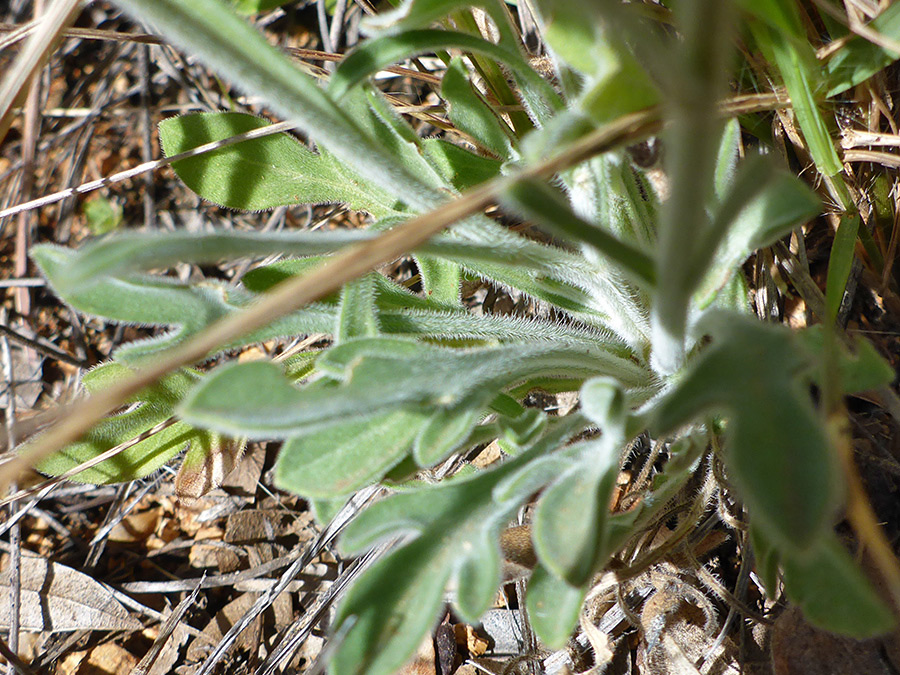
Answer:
330 416 578 675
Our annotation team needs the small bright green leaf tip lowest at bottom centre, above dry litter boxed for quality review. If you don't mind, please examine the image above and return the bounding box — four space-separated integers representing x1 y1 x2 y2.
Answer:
525 565 585 649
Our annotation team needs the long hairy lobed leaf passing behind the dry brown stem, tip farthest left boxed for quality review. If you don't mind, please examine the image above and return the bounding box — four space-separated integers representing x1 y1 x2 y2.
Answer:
32 235 629 362
